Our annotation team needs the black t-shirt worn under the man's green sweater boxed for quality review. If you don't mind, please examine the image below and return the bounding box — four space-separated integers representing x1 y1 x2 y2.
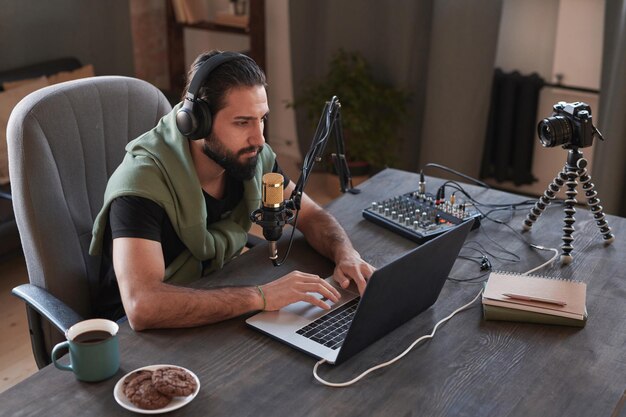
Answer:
95 163 289 320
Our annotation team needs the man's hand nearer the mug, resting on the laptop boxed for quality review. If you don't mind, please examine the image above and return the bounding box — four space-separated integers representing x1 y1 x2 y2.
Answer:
261 271 340 311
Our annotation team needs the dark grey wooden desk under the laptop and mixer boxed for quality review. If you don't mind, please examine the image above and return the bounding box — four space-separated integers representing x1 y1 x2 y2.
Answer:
0 170 626 417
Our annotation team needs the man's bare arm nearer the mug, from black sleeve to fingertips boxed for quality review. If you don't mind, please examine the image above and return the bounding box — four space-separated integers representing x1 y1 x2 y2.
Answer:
113 237 339 330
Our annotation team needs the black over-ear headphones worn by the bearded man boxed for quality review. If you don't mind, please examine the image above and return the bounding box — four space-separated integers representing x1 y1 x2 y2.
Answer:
176 52 251 140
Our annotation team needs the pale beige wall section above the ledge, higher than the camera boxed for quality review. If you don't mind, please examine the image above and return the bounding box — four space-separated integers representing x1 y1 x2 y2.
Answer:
496 0 605 89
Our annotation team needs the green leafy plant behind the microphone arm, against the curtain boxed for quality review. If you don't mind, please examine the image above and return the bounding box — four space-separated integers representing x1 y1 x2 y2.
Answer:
289 49 409 175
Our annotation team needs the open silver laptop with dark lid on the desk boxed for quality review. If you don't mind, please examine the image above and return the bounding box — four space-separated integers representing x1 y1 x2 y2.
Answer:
246 220 473 364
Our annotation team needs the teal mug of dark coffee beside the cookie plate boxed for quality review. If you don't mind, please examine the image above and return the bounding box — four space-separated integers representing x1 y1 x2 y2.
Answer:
52 319 120 382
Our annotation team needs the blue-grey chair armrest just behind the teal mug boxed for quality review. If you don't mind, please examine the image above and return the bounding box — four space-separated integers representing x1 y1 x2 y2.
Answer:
12 284 83 334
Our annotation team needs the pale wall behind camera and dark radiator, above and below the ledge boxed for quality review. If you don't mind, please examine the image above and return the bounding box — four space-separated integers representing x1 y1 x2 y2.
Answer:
487 0 605 196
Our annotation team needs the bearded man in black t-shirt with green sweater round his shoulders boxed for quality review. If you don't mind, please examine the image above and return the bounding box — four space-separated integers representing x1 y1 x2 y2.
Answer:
90 52 373 330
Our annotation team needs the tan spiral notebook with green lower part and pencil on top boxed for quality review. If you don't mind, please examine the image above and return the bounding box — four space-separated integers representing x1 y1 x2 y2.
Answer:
482 271 587 326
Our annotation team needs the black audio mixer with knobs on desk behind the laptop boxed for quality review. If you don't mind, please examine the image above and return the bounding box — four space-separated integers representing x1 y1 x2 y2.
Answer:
363 191 482 243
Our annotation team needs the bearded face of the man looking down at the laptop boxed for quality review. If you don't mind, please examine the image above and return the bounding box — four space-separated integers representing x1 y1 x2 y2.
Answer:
203 86 269 180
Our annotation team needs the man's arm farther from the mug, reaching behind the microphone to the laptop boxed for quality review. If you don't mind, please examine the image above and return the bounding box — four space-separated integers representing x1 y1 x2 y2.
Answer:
284 181 374 294
